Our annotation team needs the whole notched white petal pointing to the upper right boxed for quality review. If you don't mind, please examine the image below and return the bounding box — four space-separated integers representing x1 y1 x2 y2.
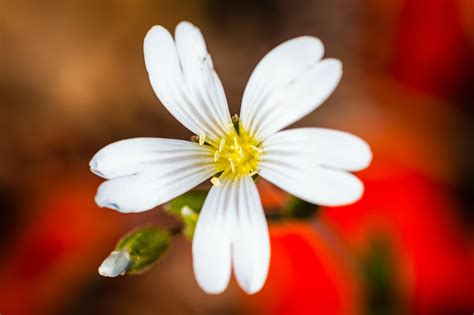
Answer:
240 36 342 139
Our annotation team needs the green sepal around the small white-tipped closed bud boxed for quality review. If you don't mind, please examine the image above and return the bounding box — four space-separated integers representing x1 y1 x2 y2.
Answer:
115 227 171 274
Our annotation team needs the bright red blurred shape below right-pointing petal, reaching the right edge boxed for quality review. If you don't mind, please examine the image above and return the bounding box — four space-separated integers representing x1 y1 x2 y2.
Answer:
323 160 474 314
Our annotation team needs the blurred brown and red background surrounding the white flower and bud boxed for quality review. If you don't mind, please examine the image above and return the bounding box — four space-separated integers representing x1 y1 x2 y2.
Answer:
0 0 474 315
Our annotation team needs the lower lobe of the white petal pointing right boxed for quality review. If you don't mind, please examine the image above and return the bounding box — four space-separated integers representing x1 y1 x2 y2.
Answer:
259 153 364 206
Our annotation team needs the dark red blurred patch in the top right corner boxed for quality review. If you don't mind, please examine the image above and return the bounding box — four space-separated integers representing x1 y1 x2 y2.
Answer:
392 0 474 97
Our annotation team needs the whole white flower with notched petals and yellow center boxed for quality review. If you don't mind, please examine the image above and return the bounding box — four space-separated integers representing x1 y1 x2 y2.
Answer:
90 22 371 294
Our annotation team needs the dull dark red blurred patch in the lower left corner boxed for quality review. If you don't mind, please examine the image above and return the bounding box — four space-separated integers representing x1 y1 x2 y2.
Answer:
0 176 125 315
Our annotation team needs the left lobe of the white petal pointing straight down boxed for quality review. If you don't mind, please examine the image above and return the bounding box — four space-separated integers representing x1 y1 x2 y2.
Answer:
193 181 233 294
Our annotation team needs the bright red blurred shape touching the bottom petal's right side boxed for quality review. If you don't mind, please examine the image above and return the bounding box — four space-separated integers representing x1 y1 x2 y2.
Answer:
244 223 358 315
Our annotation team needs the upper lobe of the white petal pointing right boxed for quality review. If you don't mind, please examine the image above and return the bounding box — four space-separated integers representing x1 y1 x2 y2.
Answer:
263 128 372 171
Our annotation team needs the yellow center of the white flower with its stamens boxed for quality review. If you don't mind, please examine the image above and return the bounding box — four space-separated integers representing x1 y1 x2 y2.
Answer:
200 116 262 184
